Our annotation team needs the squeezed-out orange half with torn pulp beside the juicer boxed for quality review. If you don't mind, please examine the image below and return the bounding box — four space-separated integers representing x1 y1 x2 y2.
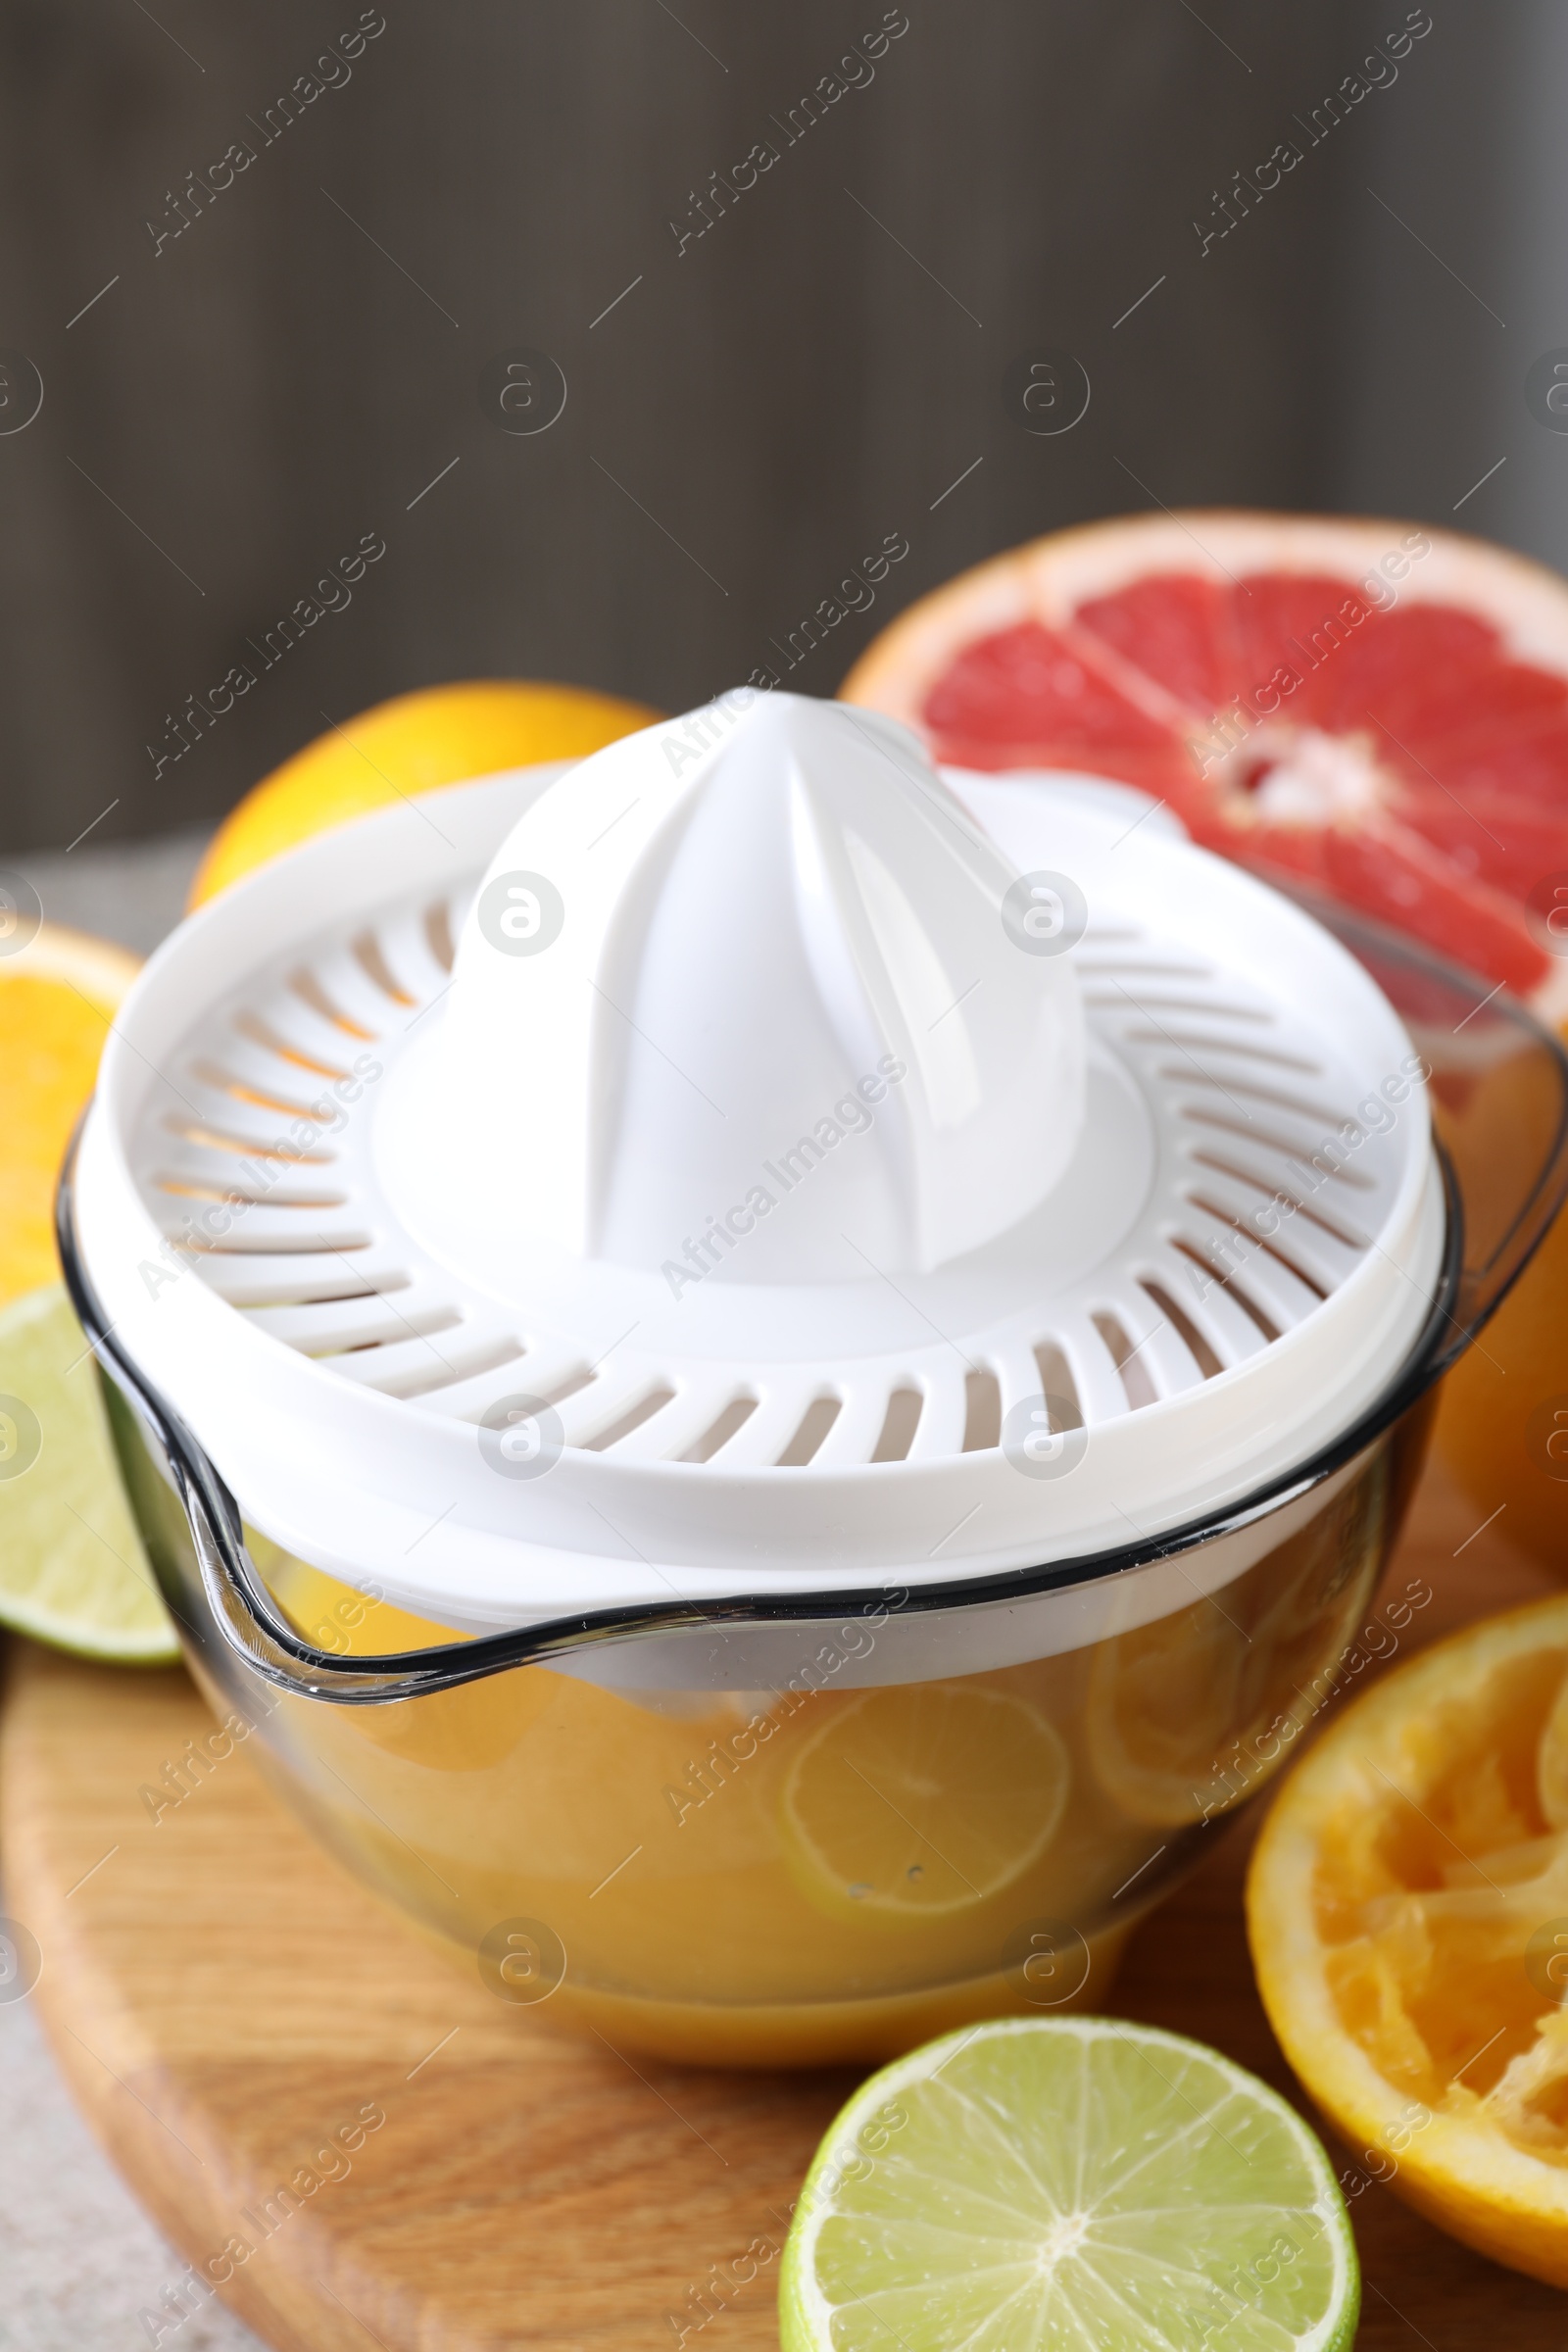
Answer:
1246 1599 1568 2286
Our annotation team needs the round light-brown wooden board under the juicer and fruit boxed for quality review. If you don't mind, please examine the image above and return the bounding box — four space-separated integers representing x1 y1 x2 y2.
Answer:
0 1475 1568 2352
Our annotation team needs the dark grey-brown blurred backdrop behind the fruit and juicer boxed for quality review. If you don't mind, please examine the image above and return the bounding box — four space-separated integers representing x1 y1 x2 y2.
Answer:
0 0 1568 865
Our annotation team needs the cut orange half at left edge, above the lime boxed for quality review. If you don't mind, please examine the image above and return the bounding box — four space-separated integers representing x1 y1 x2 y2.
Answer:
0 922 136 1305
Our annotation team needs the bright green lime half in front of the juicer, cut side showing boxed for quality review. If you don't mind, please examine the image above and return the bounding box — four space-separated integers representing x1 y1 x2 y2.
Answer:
778 2016 1361 2352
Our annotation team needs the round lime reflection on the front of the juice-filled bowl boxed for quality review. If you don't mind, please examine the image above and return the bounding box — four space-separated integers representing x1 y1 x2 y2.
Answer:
780 1682 1072 1922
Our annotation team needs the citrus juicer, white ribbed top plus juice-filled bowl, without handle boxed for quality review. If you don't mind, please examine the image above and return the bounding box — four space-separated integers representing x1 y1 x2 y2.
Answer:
61 689 1462 2058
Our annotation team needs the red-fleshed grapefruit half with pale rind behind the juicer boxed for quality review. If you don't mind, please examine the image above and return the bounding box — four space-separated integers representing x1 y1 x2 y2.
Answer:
842 513 1568 1018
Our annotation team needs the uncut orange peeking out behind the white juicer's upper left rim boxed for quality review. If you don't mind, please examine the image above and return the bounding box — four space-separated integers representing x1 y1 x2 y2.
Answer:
190 677 661 906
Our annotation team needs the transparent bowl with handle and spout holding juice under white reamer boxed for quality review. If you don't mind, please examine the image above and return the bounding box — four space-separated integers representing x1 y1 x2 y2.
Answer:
61 907 1568 2065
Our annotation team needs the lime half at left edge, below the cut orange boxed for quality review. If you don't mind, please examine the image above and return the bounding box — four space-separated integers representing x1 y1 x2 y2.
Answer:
0 1282 178 1665
